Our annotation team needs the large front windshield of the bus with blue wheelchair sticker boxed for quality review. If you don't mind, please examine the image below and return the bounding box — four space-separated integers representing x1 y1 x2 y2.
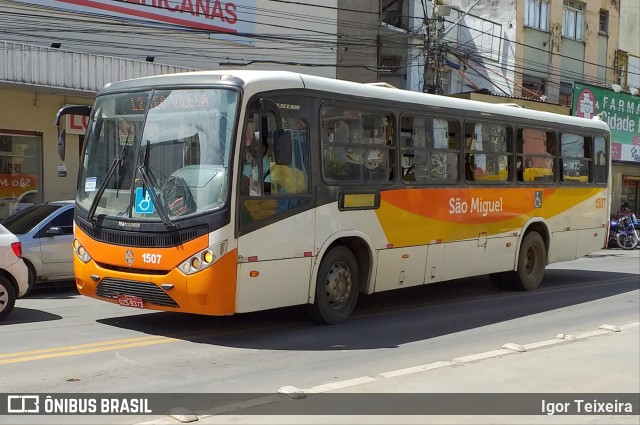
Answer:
77 88 238 224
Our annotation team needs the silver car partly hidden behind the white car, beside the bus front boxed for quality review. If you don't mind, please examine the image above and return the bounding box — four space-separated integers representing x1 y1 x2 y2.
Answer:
0 201 74 294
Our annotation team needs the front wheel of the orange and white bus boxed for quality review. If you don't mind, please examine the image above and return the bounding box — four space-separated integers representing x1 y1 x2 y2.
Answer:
308 246 360 325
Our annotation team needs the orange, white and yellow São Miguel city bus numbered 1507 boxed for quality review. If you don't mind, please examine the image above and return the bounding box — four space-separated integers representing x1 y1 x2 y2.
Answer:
56 71 611 324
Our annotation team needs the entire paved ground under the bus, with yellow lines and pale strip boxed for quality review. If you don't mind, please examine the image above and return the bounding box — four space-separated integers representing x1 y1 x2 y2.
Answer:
0 249 640 424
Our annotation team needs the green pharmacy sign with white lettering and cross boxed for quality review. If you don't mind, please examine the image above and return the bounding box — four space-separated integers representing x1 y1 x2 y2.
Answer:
572 83 640 162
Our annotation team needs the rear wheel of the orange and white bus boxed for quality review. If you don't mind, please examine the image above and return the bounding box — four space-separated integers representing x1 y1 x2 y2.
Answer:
513 232 547 291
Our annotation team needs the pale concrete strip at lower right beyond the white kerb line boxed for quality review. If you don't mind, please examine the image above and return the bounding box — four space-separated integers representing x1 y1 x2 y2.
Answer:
145 322 640 424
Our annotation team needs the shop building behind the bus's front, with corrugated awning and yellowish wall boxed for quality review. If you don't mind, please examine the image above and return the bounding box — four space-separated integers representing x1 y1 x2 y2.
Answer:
0 0 337 218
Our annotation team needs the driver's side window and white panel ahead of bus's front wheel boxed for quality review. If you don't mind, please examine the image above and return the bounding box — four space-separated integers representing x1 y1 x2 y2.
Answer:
236 102 315 312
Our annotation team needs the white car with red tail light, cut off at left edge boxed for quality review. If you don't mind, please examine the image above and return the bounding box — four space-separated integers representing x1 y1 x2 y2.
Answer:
0 224 29 320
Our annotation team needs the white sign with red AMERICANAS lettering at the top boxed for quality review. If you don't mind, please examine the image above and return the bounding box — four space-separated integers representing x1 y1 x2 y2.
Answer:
16 0 256 35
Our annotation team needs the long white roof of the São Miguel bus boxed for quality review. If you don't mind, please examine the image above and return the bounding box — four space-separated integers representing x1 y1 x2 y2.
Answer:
98 70 609 131
